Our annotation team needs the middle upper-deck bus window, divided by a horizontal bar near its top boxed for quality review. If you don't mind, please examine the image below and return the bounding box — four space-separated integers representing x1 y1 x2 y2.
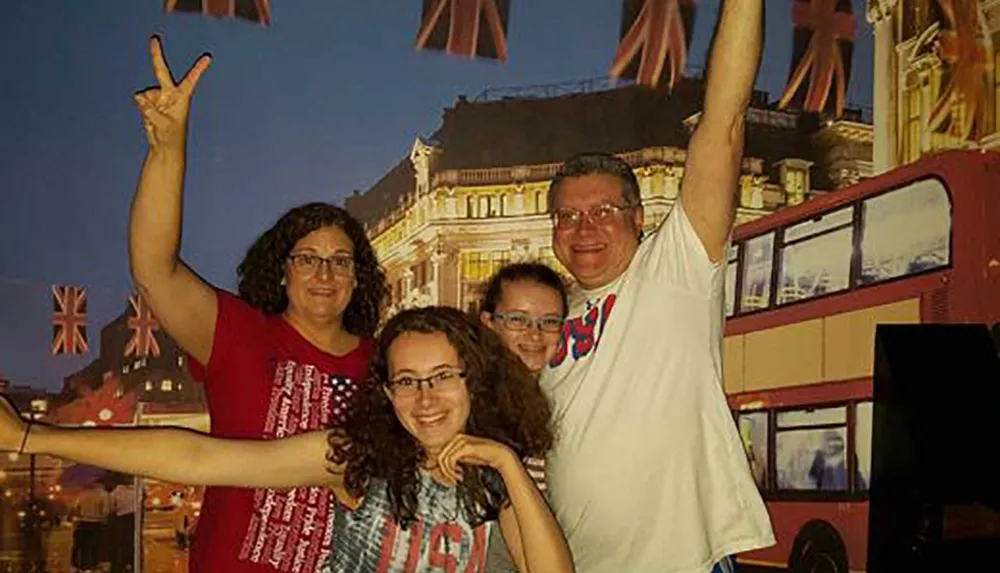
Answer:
778 207 854 304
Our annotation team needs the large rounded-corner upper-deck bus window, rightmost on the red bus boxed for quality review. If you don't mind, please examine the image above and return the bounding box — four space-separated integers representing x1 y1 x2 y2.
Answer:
860 179 951 285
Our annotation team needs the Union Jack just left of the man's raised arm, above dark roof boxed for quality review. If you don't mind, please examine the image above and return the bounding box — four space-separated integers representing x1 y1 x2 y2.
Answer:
609 0 694 88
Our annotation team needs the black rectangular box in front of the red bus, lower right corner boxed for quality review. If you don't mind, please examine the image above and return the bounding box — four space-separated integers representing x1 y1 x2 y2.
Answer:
868 324 1000 573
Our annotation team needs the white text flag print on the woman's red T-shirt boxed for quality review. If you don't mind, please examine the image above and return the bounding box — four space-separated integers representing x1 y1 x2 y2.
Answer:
239 360 357 573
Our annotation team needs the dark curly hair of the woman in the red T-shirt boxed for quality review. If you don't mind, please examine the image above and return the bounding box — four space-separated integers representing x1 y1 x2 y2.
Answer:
236 203 388 338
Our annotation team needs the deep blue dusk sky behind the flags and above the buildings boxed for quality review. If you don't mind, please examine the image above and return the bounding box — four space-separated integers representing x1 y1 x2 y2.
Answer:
0 0 872 390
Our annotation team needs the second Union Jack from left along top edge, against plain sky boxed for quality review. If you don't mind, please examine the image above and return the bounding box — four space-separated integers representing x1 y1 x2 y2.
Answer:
417 0 510 61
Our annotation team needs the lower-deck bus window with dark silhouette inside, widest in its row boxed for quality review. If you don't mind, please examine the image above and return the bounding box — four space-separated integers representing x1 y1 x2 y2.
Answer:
775 406 848 492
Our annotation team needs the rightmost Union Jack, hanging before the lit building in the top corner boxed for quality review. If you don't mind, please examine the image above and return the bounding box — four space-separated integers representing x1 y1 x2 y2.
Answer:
927 0 993 140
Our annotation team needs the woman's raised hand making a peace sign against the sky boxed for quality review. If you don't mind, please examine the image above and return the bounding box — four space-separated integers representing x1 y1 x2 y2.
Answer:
135 36 212 149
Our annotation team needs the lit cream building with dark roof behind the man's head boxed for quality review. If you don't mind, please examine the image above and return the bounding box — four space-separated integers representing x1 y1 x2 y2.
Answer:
345 79 872 313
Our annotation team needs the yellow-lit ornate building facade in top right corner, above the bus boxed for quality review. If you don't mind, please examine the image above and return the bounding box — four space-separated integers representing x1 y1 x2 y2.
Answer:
867 0 1000 173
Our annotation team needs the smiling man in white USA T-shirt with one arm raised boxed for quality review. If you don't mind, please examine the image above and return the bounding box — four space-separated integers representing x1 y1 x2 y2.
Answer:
542 0 774 573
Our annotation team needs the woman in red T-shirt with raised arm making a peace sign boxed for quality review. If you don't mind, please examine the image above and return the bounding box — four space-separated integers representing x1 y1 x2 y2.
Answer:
129 37 386 573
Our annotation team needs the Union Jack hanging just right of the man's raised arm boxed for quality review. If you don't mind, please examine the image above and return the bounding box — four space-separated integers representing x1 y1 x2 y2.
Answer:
778 0 855 117
